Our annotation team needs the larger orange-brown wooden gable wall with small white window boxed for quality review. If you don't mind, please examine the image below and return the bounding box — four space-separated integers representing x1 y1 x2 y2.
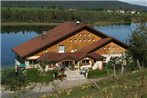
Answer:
35 28 104 56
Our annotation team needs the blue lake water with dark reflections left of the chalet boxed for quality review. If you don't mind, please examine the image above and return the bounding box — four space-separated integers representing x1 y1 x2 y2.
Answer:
1 26 54 68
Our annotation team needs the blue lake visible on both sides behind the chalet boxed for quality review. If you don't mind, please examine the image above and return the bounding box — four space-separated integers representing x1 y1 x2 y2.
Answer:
1 23 137 68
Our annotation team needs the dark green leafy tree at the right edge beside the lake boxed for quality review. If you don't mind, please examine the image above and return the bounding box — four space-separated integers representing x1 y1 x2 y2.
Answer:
128 23 147 70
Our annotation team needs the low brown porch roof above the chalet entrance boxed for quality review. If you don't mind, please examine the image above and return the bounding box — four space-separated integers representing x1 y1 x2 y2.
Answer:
39 52 104 62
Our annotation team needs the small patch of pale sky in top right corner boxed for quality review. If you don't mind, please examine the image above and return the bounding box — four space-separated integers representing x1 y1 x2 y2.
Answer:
119 0 147 6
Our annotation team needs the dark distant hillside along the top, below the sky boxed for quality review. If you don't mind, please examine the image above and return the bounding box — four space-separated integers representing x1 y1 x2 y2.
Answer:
1 1 147 11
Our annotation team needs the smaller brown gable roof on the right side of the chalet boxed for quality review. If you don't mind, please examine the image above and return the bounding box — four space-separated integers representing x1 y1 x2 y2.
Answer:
80 37 128 53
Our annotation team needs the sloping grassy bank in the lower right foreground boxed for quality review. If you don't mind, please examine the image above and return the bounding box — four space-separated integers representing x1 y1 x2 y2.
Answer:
40 69 147 98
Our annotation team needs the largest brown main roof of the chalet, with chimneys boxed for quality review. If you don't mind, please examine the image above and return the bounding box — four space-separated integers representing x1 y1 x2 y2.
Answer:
12 22 107 58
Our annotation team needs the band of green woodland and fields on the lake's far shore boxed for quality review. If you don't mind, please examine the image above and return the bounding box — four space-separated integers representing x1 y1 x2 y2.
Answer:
1 7 147 23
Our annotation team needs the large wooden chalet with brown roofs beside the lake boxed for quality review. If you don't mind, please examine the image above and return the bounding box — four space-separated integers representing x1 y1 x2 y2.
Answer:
12 22 128 69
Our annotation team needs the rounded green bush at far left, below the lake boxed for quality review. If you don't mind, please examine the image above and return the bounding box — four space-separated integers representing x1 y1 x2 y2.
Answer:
1 69 28 91
